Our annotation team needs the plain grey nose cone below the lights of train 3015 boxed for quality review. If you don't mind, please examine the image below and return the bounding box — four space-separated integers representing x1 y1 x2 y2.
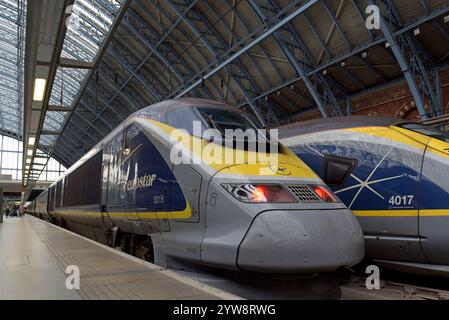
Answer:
237 209 365 273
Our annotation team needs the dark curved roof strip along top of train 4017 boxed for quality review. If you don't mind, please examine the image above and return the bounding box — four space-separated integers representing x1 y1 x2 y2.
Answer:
279 116 403 138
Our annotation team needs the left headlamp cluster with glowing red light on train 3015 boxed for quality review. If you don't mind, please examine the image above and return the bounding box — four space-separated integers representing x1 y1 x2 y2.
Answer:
222 183 298 203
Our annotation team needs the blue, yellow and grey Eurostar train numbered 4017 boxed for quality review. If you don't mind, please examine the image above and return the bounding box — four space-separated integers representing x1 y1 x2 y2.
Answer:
279 116 449 276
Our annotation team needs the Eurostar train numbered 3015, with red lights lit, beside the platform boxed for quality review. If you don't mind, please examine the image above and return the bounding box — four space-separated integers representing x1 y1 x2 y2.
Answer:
27 99 364 274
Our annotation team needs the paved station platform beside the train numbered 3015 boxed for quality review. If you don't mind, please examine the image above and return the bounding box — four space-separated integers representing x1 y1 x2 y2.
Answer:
0 215 240 300
